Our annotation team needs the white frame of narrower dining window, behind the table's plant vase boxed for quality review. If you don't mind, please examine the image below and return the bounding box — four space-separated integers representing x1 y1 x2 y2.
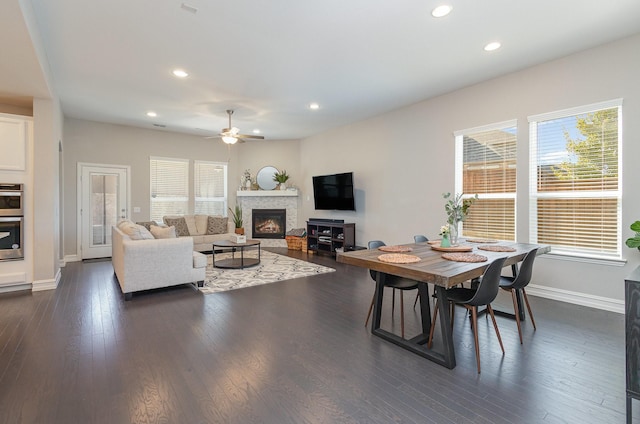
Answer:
453 119 518 241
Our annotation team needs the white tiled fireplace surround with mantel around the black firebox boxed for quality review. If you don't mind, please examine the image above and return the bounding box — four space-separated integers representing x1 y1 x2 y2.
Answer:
236 190 298 247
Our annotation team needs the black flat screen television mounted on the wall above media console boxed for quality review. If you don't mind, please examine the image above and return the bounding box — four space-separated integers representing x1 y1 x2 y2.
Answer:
313 172 356 211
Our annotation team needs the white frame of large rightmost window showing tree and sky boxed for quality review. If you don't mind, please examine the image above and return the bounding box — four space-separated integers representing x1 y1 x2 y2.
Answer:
527 99 623 262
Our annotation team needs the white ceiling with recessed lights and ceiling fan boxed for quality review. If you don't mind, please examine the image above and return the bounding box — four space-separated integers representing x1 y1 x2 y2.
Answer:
0 0 640 139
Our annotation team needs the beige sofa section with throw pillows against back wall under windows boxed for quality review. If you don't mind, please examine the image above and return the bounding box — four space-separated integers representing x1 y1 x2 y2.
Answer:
163 215 235 252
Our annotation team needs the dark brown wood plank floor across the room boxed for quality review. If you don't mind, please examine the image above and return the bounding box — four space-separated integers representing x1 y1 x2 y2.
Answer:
0 249 640 424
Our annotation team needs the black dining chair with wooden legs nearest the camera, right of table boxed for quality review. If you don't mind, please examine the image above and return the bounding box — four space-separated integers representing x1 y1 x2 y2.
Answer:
427 258 506 374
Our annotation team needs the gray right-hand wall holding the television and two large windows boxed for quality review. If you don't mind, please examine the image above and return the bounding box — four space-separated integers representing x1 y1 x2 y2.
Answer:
300 36 640 309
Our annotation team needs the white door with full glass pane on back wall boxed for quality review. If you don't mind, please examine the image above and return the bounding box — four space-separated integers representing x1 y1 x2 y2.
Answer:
78 164 129 259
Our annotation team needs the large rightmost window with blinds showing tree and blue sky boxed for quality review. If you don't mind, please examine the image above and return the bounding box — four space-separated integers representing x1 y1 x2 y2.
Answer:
529 100 622 259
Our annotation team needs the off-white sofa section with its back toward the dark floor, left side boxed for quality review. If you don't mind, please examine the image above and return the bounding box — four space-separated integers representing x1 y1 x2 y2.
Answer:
111 227 207 300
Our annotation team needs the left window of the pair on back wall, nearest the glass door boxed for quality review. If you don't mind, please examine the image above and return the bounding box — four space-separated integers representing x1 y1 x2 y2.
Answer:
150 157 189 222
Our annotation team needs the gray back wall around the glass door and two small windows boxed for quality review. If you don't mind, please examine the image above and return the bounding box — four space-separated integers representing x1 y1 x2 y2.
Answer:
63 119 299 256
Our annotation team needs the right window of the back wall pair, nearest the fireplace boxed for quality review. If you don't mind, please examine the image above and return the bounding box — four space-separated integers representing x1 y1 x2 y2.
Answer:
193 160 227 216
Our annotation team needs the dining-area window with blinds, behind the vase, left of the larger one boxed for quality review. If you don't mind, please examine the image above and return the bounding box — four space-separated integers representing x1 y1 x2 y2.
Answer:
455 120 517 240
